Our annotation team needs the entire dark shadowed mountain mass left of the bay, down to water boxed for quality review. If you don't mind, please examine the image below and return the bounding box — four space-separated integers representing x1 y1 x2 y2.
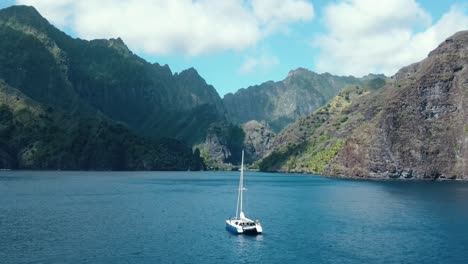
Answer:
0 6 216 170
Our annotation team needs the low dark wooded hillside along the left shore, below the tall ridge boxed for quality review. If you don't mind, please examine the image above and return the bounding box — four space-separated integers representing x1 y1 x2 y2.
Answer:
0 81 201 170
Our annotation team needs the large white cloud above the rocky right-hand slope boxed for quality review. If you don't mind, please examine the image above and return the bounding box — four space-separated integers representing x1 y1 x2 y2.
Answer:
314 0 468 76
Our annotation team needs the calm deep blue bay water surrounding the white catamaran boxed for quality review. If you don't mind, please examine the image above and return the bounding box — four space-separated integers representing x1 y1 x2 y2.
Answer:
0 171 468 263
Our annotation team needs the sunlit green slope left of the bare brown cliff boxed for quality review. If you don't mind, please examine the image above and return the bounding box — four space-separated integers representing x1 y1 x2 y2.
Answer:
259 78 386 174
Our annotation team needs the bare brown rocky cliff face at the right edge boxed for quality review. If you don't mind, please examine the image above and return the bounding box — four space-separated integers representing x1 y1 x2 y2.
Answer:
328 31 468 179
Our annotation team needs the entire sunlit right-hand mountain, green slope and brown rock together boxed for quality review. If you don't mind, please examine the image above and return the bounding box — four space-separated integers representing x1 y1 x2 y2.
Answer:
260 31 468 180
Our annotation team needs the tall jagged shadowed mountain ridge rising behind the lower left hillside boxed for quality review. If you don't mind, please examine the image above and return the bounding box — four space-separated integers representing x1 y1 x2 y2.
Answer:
0 6 225 144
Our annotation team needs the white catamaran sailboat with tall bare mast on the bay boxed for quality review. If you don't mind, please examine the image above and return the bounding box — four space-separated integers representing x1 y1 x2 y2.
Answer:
226 150 263 235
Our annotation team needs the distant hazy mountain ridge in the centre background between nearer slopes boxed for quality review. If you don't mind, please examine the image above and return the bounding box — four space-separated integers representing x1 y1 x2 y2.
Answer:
223 68 376 131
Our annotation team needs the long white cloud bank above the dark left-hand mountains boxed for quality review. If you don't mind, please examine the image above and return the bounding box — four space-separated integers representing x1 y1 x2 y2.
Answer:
17 0 313 56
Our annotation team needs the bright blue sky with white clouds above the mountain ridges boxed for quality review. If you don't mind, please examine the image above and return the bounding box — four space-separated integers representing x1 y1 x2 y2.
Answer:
0 0 468 96
